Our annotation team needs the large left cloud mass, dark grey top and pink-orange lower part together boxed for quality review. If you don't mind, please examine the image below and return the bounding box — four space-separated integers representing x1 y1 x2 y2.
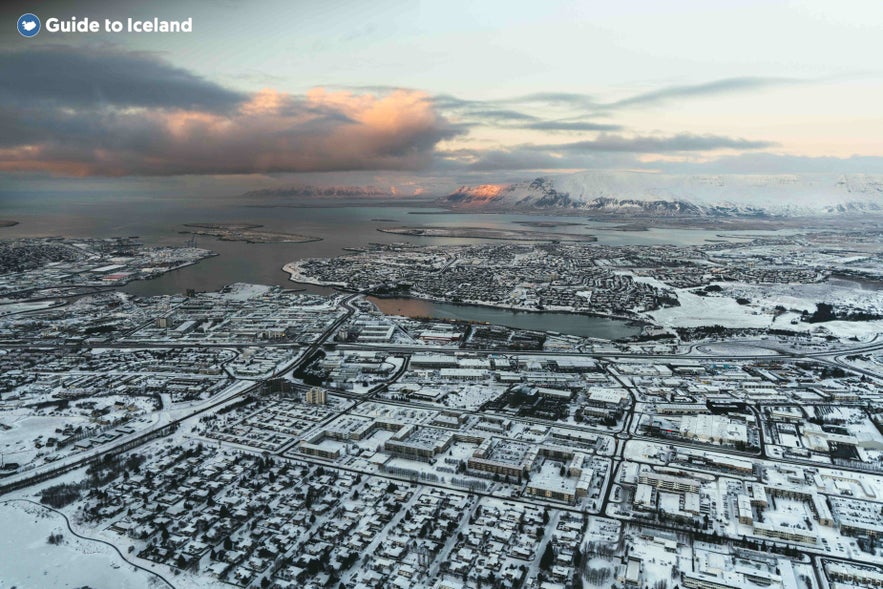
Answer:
0 48 463 176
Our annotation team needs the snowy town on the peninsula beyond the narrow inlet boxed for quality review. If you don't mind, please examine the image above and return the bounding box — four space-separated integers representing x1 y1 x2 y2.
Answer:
285 231 883 337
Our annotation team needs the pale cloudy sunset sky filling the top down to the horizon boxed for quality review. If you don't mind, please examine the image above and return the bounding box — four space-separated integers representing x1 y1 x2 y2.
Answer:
0 0 883 194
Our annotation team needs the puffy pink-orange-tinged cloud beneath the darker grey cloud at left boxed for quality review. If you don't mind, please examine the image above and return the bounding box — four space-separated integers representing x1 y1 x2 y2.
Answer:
0 89 456 176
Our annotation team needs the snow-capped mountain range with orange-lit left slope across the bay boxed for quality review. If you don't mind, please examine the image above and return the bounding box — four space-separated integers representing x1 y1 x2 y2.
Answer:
442 171 883 216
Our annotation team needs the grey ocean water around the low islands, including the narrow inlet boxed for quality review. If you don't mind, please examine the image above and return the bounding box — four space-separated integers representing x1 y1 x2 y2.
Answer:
0 194 796 338
